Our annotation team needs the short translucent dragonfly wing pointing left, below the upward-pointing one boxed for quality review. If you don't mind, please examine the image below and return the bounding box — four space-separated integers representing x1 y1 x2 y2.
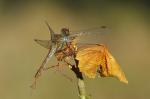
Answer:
35 39 51 49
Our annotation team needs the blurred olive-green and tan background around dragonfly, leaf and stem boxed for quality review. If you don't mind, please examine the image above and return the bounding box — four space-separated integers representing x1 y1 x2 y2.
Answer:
0 0 150 99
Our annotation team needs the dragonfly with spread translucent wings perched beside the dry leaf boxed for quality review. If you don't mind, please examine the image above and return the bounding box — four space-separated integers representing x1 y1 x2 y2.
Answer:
35 22 107 81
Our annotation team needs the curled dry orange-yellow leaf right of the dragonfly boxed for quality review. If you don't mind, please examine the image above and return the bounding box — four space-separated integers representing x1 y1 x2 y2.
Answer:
76 44 128 83
